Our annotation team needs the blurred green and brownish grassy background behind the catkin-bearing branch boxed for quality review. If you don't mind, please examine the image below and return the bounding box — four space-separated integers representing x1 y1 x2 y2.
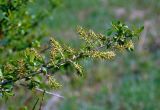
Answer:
0 0 160 110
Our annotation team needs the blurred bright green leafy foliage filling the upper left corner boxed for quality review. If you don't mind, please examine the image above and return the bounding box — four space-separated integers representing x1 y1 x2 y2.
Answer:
0 0 60 63
